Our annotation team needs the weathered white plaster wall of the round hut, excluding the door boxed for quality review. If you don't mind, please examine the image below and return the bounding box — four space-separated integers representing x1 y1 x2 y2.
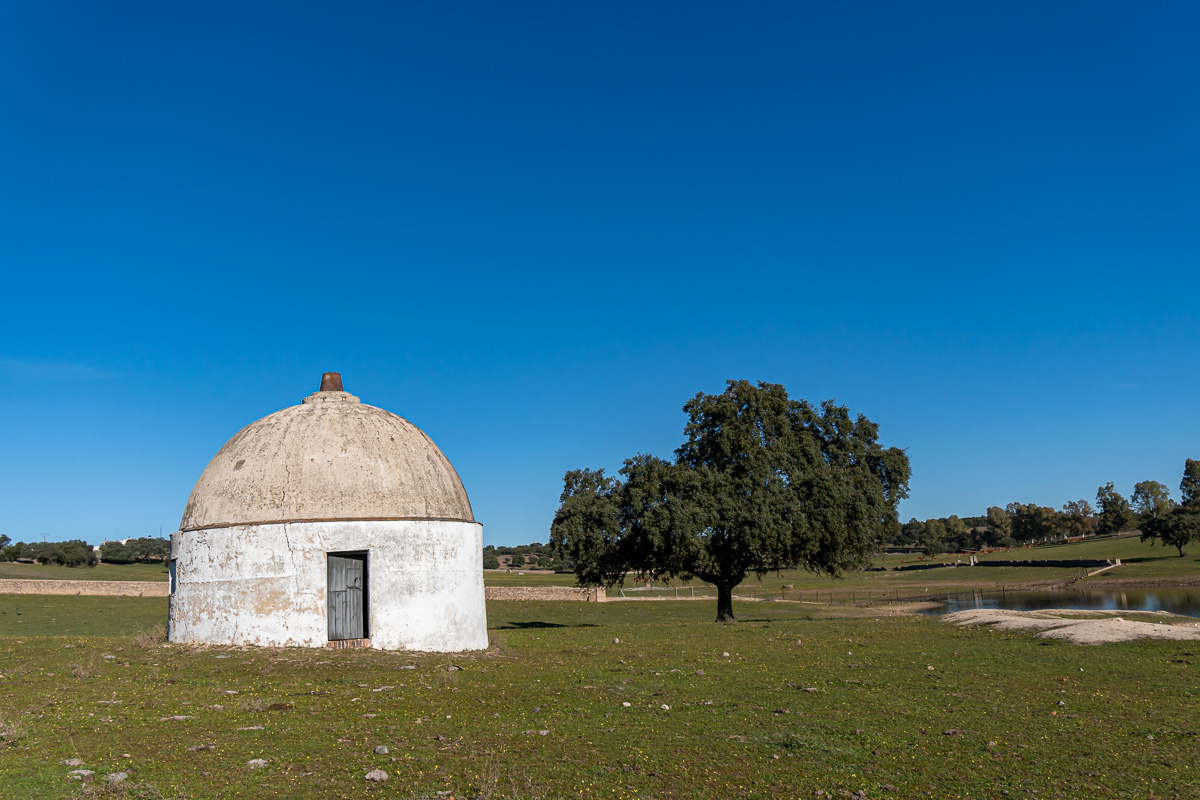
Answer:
169 521 487 652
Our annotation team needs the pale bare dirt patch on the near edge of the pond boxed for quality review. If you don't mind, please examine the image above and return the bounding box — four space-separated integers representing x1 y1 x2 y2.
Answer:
942 608 1200 644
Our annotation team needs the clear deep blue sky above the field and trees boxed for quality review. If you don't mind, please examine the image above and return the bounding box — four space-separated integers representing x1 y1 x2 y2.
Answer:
0 0 1200 545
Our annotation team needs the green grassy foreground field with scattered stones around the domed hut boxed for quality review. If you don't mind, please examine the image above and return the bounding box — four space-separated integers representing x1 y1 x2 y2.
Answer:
0 597 1200 799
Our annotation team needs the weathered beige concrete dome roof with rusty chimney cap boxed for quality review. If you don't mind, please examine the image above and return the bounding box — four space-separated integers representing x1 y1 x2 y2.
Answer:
179 373 475 530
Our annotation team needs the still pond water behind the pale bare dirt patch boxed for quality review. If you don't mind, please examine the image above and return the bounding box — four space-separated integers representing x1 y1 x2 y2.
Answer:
924 587 1200 618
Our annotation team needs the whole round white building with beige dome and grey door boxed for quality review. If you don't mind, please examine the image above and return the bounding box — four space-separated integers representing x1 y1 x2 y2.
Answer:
169 373 487 652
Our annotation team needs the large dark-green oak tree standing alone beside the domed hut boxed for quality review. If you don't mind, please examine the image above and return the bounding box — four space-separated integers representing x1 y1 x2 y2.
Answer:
551 380 910 621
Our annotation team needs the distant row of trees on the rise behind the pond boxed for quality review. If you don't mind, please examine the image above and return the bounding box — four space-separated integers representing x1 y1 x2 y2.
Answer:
883 458 1200 557
